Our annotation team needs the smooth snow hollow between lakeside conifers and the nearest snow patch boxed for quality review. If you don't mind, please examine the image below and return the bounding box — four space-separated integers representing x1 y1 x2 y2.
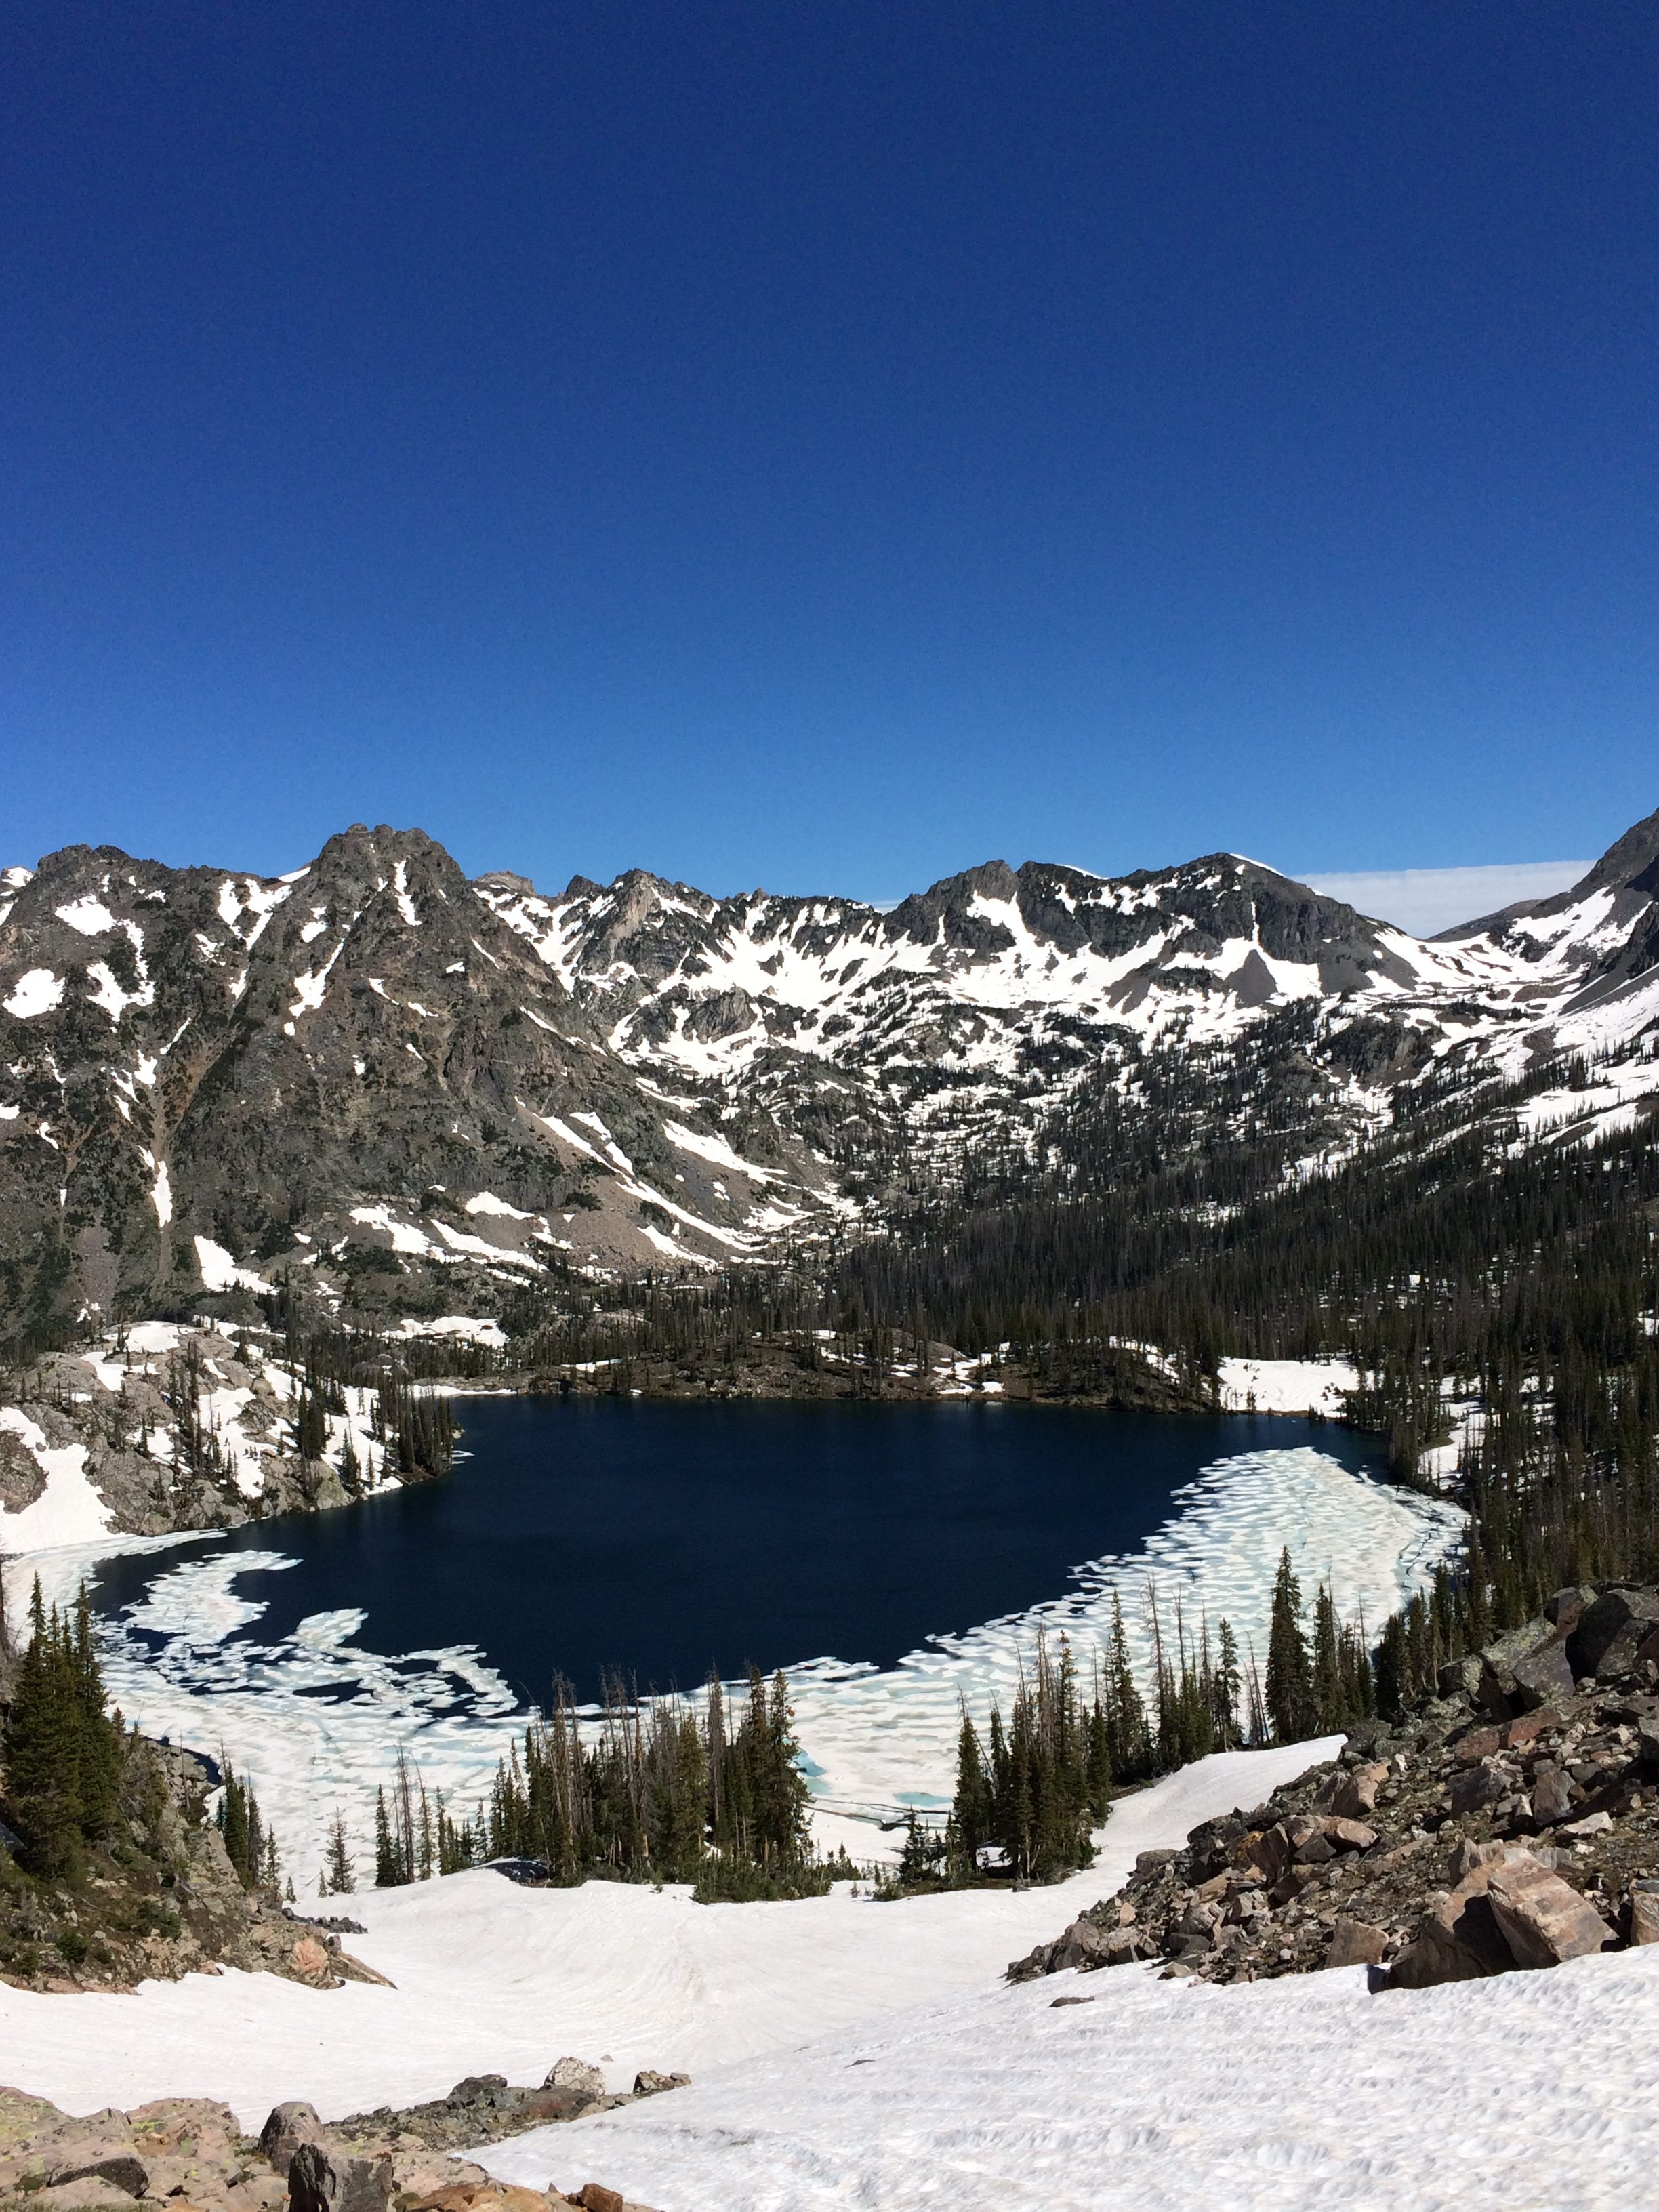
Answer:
0 1739 1338 2123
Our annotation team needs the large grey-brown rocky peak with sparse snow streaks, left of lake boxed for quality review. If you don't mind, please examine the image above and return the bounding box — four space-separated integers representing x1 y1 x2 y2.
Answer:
0 827 823 1347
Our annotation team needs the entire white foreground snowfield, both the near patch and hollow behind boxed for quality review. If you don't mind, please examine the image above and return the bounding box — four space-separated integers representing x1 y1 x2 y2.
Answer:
0 1745 1659 2212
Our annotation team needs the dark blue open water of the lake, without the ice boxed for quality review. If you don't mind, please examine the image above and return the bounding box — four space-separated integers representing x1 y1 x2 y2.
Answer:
98 1398 1380 1701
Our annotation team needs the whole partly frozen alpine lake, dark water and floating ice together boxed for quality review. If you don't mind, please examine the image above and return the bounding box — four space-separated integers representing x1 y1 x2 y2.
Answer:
9 1400 1462 1893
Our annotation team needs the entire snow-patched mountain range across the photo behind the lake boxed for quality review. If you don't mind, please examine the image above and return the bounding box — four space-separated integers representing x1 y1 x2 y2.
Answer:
0 814 1659 1349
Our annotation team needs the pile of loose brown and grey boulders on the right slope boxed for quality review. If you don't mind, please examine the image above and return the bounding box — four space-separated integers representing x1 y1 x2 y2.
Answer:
1008 1586 1659 1988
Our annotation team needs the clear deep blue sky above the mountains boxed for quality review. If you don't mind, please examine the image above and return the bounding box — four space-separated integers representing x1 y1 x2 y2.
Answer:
0 0 1659 896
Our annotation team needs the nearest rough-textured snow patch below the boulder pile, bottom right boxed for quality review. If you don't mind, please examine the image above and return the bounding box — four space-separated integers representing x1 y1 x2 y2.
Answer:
478 1949 1659 2212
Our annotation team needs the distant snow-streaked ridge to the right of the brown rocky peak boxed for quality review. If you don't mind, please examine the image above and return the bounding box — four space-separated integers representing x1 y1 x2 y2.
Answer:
478 816 1659 1170
